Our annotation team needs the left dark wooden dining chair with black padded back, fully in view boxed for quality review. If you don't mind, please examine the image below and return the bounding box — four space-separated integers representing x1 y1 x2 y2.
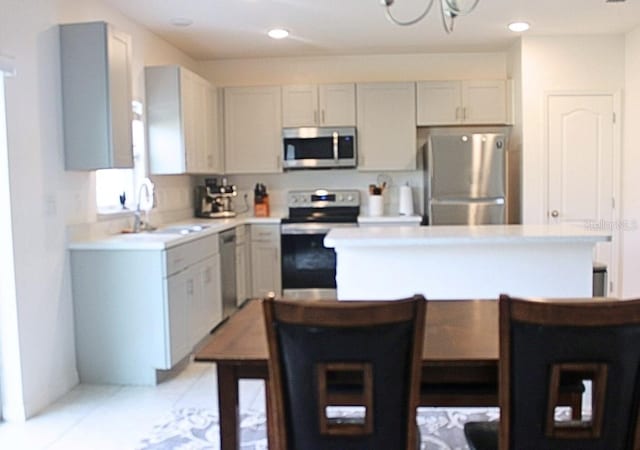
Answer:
263 295 427 450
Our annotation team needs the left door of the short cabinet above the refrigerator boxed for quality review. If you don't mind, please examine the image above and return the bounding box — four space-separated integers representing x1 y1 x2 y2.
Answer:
416 81 462 126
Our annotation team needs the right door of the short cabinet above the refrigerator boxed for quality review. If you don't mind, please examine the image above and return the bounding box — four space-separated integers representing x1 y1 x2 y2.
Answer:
462 80 507 124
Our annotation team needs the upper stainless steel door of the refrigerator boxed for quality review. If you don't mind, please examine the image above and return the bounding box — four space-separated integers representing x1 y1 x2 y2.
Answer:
427 133 506 200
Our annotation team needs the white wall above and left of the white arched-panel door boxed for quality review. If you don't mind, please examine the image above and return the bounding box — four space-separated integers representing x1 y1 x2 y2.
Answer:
522 36 625 223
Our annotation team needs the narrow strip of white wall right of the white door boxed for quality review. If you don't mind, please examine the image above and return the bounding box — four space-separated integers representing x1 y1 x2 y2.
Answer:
622 27 640 297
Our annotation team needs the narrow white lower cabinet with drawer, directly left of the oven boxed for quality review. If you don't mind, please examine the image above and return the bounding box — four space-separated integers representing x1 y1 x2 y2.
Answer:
251 224 282 298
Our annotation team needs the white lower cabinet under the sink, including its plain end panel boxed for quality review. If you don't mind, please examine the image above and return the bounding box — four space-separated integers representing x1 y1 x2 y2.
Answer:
71 234 222 385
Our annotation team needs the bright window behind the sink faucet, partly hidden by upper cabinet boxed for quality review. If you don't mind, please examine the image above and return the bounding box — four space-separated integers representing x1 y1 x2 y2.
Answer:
96 101 147 214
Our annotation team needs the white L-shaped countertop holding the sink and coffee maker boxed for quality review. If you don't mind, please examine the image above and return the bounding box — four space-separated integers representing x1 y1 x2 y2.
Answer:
68 216 280 250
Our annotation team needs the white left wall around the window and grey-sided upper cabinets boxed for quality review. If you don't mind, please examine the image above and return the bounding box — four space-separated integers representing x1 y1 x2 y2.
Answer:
0 0 197 419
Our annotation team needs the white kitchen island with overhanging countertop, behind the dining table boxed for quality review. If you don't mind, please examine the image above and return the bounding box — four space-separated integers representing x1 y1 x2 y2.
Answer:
324 225 611 300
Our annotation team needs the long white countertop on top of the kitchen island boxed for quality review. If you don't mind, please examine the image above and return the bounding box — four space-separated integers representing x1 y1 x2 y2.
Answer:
324 225 611 248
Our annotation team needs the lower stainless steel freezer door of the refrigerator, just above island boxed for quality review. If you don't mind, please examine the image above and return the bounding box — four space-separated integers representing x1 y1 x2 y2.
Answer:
429 198 506 225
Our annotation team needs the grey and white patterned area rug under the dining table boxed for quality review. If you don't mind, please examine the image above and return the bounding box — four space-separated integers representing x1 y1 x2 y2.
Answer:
136 408 499 450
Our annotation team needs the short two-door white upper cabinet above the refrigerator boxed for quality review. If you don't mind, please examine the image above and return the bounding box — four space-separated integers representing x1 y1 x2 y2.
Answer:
416 80 509 126
